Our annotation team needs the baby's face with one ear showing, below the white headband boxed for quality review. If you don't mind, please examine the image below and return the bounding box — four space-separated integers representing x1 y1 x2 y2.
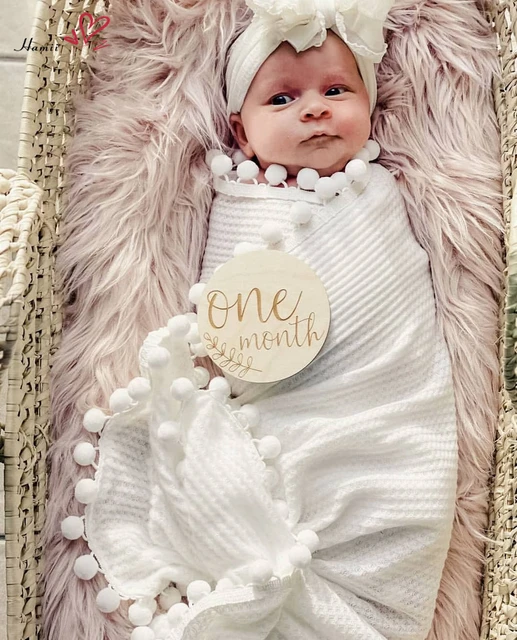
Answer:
230 31 371 176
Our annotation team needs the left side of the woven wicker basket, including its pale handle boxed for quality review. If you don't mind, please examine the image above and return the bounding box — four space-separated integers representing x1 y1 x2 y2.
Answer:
0 0 108 640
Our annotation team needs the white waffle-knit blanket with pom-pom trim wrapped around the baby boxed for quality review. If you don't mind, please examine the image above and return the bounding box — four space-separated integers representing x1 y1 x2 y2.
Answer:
86 165 457 640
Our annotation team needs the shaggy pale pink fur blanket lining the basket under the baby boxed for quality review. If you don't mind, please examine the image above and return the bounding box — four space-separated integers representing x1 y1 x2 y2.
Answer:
44 0 503 640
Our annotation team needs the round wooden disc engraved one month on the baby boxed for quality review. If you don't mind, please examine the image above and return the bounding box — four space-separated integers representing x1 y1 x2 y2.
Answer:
197 249 330 382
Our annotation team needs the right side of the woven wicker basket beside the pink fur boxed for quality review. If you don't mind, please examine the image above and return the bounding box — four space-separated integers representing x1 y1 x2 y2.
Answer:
481 0 517 640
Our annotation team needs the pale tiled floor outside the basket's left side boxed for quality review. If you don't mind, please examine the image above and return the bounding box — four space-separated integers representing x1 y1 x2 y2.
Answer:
0 0 38 640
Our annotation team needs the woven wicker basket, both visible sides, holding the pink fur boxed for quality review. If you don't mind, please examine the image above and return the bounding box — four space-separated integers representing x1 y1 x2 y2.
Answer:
0 0 517 640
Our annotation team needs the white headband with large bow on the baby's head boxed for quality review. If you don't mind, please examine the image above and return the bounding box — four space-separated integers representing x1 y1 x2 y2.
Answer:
226 0 393 117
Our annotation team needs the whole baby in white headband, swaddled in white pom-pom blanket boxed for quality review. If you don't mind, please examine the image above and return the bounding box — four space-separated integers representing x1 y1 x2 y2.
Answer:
78 0 457 640
